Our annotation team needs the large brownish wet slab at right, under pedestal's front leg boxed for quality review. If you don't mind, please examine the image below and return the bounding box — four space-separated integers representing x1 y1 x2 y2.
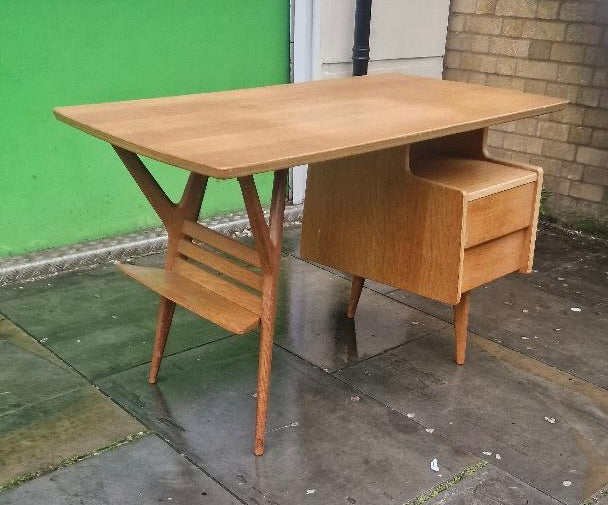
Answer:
337 324 608 504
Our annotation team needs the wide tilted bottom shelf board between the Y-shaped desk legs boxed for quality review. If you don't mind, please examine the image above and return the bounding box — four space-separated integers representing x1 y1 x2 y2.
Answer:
119 265 260 334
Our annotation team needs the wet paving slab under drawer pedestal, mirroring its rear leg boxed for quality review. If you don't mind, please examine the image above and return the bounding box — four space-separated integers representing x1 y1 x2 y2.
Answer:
275 257 437 371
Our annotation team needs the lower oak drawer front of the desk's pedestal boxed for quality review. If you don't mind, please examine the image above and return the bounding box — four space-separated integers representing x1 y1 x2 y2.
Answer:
461 229 529 293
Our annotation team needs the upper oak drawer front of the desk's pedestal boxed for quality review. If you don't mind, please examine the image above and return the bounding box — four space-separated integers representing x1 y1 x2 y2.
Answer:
465 182 536 248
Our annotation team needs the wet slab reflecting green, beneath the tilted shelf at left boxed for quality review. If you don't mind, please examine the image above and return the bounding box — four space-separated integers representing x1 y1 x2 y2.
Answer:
0 255 229 379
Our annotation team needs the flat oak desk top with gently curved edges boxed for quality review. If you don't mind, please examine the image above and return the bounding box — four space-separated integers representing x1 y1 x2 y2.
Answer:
54 74 566 178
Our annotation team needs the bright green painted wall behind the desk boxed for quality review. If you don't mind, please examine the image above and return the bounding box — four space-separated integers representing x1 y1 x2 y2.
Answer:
0 0 289 257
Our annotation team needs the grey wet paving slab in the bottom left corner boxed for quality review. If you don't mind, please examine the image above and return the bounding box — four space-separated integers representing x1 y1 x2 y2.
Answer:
0 436 241 505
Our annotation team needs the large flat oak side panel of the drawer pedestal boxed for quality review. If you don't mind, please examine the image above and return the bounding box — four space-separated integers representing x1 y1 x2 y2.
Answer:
301 147 465 305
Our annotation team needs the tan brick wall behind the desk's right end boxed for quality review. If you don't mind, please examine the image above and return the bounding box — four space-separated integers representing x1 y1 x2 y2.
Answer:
444 0 608 223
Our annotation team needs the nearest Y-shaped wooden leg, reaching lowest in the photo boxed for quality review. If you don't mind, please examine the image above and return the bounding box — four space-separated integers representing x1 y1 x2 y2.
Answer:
239 170 287 456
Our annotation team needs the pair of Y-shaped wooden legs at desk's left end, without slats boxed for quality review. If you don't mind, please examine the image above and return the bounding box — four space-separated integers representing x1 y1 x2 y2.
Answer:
113 146 287 456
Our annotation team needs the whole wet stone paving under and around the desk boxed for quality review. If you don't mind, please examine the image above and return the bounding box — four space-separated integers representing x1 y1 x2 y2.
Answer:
0 227 608 505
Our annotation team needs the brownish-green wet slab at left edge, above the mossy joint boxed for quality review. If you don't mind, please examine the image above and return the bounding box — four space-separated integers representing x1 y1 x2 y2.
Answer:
0 386 144 485
